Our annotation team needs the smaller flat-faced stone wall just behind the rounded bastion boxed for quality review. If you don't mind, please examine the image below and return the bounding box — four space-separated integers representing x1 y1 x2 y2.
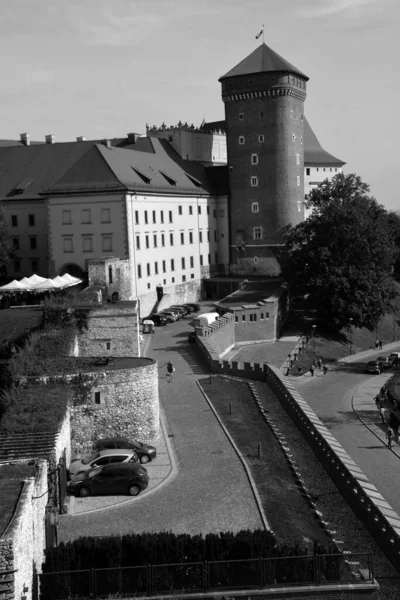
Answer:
74 302 140 357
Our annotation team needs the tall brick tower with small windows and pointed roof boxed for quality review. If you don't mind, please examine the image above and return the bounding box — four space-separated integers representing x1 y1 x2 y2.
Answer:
219 43 308 275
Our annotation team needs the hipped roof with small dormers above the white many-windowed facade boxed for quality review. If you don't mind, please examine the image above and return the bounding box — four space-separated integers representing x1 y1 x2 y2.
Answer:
44 138 226 195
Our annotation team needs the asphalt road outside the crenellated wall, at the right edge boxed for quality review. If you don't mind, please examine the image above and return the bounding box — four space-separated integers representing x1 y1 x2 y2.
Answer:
291 344 400 514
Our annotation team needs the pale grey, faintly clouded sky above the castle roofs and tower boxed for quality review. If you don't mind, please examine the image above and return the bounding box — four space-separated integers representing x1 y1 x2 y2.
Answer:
0 0 400 210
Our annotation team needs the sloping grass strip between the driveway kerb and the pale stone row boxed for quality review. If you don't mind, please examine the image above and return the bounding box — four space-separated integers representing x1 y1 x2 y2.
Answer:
200 377 330 547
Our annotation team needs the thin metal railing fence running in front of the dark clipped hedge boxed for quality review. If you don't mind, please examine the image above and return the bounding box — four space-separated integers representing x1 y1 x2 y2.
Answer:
38 553 373 600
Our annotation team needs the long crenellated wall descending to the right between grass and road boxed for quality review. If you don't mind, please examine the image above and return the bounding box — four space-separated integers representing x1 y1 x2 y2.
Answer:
197 338 400 569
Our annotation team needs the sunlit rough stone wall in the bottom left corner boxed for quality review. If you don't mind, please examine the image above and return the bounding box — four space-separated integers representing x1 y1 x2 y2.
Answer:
0 460 48 600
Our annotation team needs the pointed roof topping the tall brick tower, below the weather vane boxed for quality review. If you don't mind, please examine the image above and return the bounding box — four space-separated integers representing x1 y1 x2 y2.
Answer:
218 44 309 81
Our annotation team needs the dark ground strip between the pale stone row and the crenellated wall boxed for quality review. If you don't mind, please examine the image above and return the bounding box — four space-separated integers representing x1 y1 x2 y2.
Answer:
254 382 400 600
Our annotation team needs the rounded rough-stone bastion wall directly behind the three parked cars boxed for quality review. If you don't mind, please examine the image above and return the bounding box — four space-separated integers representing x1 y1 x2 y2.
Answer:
71 358 160 455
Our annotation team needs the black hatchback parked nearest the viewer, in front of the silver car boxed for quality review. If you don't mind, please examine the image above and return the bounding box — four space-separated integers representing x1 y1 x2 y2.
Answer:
68 463 149 498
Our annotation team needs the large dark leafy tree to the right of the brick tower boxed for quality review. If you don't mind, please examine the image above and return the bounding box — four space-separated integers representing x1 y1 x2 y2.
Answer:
284 173 397 329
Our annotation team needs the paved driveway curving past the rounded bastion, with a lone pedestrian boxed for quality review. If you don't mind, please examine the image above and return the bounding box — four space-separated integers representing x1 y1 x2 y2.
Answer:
59 308 262 541
